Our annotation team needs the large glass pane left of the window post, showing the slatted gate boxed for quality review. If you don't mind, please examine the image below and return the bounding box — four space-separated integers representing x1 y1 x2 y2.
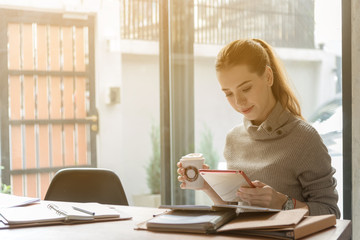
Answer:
0 0 160 207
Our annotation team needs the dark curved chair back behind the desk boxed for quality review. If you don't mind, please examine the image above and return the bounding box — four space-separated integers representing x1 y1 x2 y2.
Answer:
45 168 129 205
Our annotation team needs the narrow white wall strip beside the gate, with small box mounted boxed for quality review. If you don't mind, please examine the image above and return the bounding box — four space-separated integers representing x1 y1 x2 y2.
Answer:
95 1 126 195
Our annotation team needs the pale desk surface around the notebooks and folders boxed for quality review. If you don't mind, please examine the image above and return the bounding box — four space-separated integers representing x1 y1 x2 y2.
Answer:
0 206 352 240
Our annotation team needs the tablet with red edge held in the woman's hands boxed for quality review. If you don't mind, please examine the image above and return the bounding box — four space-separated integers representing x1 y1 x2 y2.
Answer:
199 169 255 202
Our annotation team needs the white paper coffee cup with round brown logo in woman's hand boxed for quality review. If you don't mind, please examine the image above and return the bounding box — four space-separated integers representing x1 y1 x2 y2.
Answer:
180 153 205 189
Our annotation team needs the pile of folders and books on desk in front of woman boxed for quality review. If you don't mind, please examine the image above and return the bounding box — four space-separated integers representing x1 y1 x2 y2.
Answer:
138 205 336 239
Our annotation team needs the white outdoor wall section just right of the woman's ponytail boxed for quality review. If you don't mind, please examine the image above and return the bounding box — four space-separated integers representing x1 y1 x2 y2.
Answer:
275 48 336 118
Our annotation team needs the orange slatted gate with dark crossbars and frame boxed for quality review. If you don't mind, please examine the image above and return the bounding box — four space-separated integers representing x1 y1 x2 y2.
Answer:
0 9 97 197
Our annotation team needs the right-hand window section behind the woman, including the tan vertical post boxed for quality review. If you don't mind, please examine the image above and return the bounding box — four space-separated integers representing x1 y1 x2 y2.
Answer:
162 0 342 216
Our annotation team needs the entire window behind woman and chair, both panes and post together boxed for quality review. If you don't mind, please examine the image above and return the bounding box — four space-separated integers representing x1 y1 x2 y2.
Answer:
0 0 343 218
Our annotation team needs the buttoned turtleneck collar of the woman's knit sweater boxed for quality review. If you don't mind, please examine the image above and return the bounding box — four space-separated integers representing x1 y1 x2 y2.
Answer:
244 102 295 140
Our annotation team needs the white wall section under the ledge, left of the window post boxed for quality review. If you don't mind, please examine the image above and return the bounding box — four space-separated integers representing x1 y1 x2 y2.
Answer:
118 54 160 202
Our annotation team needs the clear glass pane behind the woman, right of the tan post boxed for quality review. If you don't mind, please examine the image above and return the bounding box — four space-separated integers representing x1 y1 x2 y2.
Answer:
170 0 342 215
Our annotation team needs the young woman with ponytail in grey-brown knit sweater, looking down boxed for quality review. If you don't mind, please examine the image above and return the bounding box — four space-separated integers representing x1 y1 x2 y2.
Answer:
178 39 340 218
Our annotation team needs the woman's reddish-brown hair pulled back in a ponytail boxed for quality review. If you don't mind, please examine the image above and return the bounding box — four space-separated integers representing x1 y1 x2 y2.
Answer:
215 39 304 119
